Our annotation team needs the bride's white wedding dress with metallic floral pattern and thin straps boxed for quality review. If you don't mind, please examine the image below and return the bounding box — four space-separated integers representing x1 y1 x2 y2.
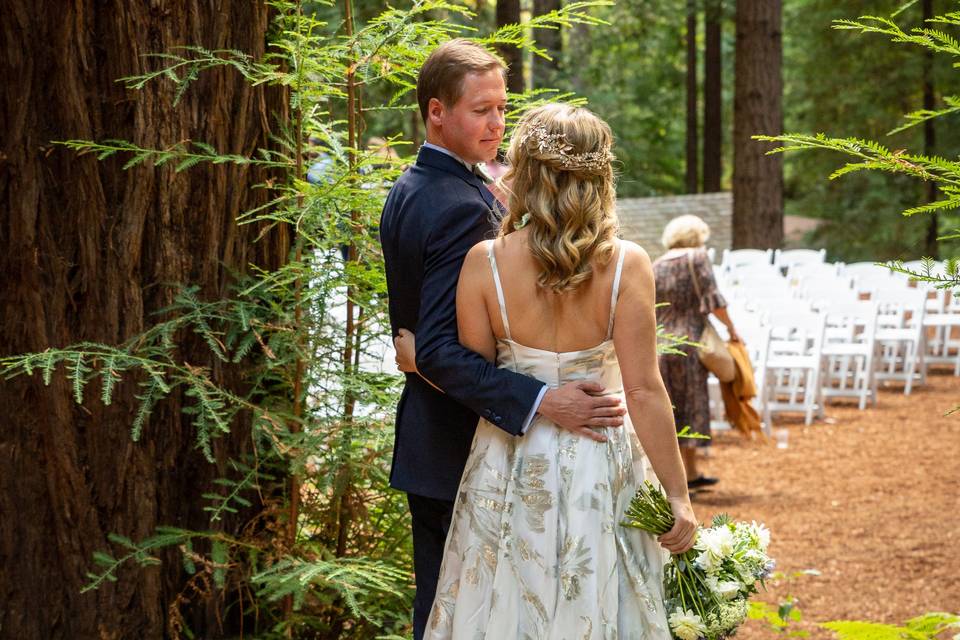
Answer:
425 241 670 640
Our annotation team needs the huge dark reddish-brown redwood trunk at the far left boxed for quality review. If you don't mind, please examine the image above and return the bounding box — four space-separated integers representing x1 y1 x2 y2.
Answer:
0 0 289 640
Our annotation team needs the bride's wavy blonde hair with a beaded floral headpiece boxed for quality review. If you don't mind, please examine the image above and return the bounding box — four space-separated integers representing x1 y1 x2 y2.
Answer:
499 104 618 293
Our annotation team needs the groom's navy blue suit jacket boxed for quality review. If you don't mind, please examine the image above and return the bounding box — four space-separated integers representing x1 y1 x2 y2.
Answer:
380 147 543 500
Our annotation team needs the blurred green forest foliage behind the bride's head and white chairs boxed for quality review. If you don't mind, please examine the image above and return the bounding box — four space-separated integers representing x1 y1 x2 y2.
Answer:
352 0 960 262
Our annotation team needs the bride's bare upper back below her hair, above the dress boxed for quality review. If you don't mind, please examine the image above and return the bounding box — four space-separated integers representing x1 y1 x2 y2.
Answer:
483 230 621 352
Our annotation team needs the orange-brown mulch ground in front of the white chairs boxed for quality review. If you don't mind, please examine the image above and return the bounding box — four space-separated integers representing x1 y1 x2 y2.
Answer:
694 364 960 640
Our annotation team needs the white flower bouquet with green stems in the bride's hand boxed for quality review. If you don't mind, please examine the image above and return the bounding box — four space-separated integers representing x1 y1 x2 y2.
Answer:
620 481 774 640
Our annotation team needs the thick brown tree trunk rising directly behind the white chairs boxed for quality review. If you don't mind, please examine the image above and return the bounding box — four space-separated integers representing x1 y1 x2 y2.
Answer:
733 0 783 248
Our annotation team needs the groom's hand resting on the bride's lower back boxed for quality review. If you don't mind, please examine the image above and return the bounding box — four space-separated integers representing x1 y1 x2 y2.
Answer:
538 382 627 442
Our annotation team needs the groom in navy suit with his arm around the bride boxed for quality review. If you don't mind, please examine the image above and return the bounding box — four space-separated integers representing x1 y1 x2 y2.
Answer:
380 39 624 640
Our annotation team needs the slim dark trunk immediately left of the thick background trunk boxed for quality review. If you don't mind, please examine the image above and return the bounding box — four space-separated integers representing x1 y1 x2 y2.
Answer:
703 0 723 193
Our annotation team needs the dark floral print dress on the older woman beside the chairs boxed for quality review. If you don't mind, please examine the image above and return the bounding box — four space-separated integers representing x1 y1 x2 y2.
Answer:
653 248 727 447
